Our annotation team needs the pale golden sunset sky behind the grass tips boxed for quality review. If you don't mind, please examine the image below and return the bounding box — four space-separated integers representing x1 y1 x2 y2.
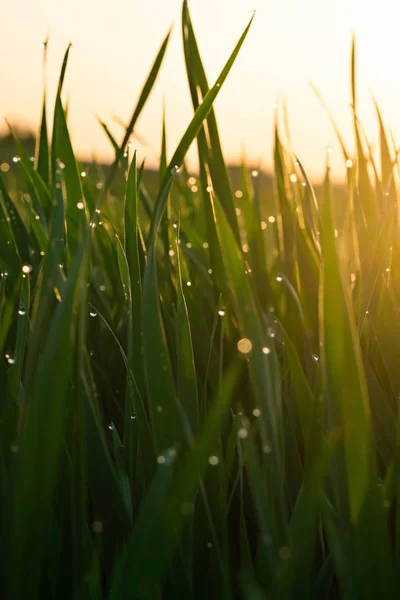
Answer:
0 0 400 176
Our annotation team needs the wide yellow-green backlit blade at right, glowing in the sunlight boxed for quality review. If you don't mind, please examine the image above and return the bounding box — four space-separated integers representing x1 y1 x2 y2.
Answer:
320 174 376 522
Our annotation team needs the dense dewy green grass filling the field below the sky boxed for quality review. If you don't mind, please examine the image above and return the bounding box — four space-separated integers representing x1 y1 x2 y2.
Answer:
0 1 400 600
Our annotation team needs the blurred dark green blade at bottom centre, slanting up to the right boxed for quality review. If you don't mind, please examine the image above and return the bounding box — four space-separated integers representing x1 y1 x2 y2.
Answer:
111 365 236 600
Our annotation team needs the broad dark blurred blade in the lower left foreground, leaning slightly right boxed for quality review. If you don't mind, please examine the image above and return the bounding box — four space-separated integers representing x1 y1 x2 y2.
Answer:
9 231 88 598
